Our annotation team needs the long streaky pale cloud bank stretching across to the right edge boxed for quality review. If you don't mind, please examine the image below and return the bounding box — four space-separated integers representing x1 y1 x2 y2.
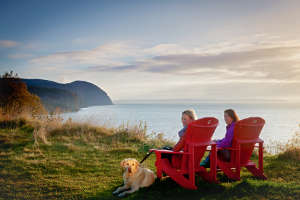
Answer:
30 35 300 86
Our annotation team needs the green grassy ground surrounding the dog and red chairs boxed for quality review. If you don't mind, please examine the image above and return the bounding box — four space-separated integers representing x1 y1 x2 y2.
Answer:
0 117 300 199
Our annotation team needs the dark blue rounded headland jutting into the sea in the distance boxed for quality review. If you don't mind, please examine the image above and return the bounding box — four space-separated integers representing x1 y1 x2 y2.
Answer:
22 79 113 111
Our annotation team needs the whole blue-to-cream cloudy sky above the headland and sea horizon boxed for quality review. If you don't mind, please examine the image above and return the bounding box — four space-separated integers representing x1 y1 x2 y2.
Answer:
0 0 300 102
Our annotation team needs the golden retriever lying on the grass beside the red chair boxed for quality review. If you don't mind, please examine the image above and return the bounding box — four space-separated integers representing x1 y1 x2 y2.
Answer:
113 158 156 197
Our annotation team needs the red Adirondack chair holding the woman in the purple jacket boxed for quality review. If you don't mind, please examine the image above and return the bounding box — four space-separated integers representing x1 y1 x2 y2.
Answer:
217 117 266 180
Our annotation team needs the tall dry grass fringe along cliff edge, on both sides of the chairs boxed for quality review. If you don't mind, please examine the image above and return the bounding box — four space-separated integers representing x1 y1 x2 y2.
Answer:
0 110 300 158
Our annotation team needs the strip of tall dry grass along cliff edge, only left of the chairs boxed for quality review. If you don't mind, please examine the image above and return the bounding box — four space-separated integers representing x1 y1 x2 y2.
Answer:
0 113 173 152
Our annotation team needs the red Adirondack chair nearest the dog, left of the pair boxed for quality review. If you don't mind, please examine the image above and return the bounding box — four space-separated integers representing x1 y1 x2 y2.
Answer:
150 117 218 190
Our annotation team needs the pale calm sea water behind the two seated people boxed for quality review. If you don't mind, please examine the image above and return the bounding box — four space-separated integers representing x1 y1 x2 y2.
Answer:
62 103 300 144
